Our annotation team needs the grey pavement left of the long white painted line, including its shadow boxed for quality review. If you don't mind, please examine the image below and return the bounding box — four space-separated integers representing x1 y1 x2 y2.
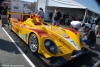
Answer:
0 23 34 67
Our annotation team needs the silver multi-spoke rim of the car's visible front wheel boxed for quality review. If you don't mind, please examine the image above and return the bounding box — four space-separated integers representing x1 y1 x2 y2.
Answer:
29 34 38 52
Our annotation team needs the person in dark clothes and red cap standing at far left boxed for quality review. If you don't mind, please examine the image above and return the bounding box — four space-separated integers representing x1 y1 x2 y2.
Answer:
1 2 8 27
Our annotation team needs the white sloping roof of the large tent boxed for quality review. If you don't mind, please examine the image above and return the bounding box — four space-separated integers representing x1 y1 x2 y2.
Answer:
46 0 86 9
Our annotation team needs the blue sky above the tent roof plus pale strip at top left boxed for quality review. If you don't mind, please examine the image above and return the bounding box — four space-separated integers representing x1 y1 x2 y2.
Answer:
24 0 100 14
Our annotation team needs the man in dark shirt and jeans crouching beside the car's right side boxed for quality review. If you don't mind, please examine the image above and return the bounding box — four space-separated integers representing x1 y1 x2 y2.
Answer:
83 26 96 48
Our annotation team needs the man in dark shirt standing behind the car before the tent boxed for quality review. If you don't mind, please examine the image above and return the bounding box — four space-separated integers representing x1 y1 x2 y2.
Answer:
52 8 62 25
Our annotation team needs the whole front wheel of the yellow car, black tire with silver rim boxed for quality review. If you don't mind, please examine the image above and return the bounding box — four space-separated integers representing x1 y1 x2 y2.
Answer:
28 33 39 53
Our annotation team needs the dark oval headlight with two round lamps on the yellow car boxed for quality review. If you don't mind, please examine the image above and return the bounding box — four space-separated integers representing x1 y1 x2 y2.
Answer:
44 39 58 54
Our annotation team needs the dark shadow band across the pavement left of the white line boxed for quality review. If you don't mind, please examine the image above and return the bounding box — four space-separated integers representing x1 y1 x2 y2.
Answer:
0 39 20 54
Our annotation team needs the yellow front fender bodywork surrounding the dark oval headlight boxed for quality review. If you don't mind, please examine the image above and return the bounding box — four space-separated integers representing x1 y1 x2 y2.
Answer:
39 35 72 58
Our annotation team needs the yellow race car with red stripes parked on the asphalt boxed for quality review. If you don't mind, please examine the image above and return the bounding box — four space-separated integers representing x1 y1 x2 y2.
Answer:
9 15 88 67
